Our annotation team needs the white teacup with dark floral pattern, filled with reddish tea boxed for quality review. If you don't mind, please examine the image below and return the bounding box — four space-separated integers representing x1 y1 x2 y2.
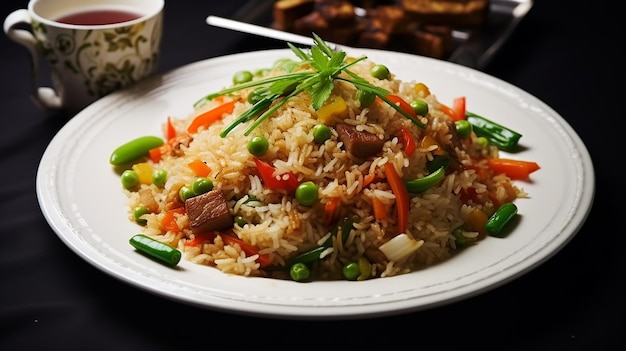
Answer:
4 0 164 112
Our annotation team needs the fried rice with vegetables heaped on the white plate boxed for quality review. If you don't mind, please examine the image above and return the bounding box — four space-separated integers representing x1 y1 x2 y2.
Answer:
118 49 527 280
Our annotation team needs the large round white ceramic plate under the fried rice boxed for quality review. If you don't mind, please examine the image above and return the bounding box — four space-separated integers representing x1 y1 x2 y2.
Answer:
37 49 595 319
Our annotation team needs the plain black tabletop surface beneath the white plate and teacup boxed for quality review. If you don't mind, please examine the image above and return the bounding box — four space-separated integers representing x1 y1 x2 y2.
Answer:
0 0 626 351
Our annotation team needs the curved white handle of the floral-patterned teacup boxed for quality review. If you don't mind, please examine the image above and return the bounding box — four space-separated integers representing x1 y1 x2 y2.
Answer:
4 9 61 109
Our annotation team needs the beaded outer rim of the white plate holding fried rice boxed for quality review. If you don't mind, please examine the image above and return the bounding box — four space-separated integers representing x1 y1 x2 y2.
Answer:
36 49 595 319
